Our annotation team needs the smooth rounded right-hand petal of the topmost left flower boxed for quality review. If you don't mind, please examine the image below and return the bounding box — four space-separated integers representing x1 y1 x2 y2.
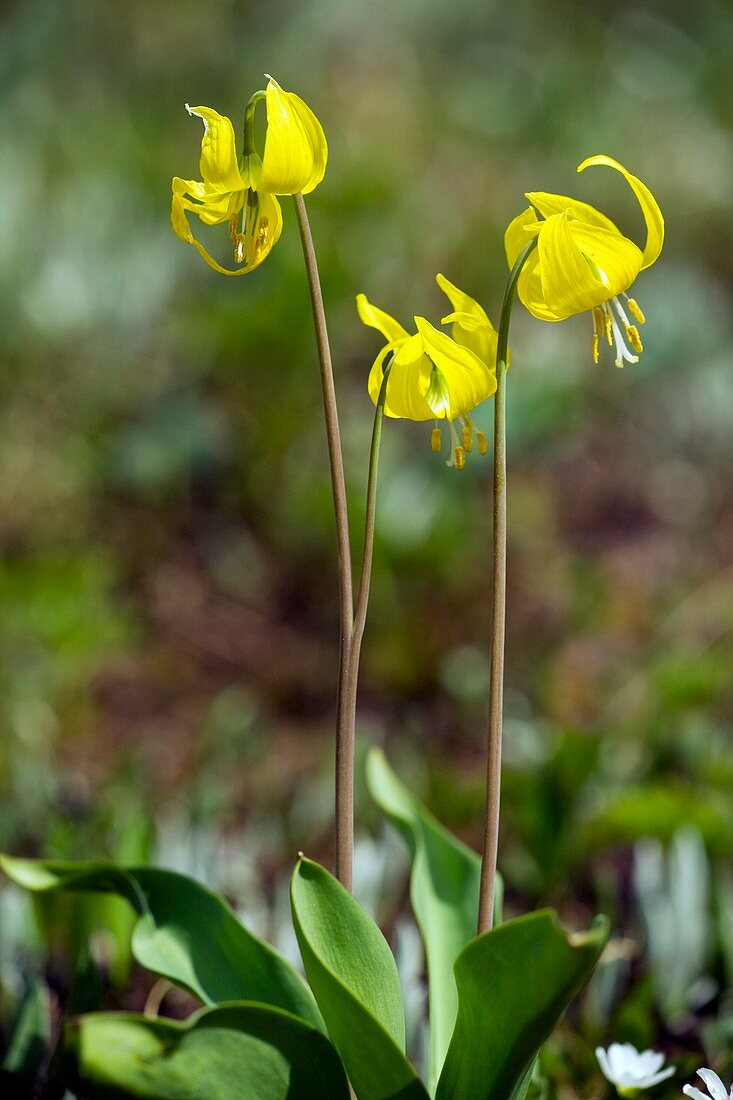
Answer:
258 78 328 195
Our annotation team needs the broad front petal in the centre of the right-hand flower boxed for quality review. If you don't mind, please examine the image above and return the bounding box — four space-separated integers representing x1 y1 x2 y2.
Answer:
530 213 611 320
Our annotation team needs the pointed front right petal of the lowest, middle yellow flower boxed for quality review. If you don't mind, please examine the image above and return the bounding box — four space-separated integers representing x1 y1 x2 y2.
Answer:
415 317 496 419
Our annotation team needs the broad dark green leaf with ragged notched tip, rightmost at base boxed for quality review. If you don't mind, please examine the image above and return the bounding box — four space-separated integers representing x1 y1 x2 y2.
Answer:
436 911 609 1100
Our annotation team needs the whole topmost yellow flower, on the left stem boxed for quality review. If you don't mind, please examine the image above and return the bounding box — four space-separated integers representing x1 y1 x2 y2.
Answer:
171 77 328 275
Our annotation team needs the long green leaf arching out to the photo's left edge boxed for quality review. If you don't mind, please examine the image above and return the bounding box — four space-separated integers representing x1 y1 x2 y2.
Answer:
0 856 324 1031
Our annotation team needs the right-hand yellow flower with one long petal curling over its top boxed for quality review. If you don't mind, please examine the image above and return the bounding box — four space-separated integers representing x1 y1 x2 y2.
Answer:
504 156 665 366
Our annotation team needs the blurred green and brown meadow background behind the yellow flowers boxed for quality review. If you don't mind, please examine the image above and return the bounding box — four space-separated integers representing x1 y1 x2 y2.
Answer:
0 0 733 1096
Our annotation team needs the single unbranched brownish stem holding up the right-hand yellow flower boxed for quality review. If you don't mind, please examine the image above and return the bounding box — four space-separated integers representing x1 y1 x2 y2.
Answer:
478 238 537 935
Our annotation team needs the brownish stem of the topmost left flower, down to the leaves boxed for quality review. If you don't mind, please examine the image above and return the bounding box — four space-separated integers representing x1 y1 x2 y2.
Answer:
293 195 354 890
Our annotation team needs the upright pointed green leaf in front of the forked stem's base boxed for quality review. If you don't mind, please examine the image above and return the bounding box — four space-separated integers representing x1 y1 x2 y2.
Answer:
291 858 427 1100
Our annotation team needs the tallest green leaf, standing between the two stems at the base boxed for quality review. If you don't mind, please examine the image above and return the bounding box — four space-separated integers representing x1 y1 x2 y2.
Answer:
367 749 501 1091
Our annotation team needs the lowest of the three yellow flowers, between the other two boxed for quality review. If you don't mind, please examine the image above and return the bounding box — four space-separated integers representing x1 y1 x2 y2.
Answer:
357 292 496 470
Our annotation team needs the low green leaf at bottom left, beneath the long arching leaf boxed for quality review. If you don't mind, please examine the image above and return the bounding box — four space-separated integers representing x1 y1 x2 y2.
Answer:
59 1003 349 1100
